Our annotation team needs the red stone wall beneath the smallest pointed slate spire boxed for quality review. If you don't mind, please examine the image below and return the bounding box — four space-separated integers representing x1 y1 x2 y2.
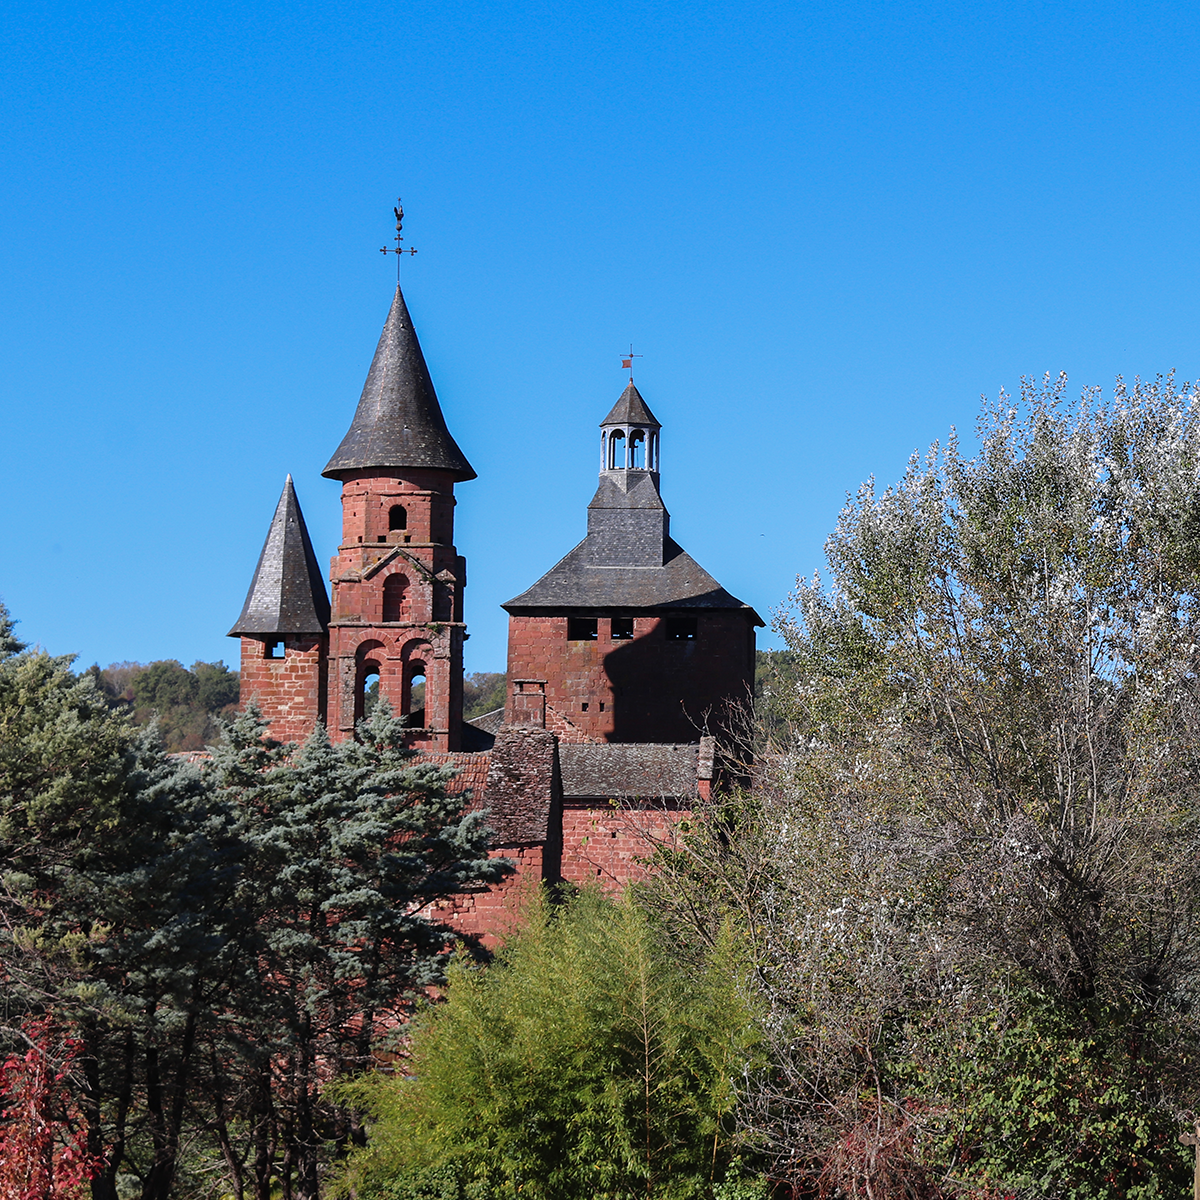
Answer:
241 634 328 742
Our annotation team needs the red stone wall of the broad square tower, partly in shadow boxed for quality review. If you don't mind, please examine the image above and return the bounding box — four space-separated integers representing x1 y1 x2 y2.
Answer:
506 610 754 742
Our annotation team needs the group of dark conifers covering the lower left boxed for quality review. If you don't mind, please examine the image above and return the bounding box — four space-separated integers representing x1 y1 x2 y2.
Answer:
0 608 506 1200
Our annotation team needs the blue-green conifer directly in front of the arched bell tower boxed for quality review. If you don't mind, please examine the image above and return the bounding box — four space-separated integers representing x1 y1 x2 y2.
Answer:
206 702 511 1200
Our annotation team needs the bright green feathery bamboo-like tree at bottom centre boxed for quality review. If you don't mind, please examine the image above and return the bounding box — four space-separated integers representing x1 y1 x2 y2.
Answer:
341 892 755 1200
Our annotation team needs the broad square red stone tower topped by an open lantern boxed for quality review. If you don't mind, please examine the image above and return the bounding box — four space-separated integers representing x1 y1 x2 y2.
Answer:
504 383 762 744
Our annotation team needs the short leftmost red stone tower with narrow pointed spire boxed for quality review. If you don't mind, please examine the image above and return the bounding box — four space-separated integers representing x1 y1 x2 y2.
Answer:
229 475 329 742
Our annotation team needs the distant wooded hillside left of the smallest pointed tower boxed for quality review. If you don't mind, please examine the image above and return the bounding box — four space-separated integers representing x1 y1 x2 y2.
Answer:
86 659 239 751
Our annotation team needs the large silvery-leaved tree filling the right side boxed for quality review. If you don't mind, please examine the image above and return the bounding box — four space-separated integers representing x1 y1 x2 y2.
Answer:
660 379 1200 1200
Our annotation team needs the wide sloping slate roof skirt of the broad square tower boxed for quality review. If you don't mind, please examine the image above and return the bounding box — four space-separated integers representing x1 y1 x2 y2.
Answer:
502 538 762 625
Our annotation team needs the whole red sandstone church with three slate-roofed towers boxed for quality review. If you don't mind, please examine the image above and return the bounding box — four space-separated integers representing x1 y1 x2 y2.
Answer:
229 280 762 932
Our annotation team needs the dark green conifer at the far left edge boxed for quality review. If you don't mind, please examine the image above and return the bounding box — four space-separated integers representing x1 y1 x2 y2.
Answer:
0 610 241 1200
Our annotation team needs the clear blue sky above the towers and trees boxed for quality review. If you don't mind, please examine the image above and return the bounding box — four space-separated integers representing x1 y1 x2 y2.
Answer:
0 0 1200 671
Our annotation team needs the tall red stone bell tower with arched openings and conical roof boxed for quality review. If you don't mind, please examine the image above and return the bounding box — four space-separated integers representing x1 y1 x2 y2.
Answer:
322 284 475 751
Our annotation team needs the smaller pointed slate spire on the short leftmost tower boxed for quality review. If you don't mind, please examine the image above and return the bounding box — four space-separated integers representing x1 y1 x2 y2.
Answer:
229 475 329 637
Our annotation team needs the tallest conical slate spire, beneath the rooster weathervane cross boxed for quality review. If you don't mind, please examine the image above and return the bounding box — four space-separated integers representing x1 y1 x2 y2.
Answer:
322 284 475 480
